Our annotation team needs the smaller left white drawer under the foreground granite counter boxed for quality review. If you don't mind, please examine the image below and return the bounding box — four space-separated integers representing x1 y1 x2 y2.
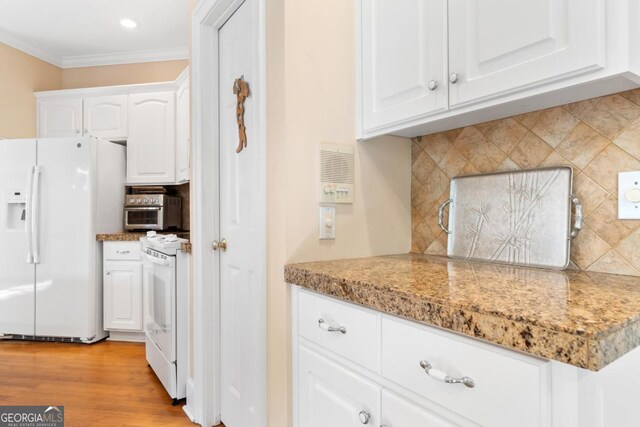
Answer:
298 291 380 372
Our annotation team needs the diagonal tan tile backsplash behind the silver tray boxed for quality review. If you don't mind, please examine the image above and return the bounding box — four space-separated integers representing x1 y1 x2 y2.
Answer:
411 89 640 276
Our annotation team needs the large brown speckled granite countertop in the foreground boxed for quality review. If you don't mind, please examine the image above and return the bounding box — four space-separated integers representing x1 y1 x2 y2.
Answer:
285 254 640 371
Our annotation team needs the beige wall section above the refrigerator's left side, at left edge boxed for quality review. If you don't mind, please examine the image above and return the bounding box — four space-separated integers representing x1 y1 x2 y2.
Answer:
0 43 62 138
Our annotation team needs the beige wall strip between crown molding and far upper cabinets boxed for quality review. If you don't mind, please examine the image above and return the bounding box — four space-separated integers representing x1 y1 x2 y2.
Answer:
62 60 189 89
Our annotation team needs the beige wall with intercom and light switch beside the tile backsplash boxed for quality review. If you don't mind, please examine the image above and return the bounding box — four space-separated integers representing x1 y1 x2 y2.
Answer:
267 0 411 427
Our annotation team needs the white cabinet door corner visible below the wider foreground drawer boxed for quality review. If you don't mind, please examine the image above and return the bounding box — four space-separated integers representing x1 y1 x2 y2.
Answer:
381 390 455 427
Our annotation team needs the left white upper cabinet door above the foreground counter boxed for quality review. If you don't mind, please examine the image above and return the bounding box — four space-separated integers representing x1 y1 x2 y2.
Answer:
360 0 447 136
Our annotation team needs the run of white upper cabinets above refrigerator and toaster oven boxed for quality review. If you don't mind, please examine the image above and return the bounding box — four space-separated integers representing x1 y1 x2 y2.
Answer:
35 74 191 185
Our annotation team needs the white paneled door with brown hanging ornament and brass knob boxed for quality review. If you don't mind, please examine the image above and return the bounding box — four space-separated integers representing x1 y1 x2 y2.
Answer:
218 2 265 427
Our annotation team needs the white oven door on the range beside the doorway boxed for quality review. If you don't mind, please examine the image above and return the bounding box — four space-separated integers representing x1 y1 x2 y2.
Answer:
142 252 176 362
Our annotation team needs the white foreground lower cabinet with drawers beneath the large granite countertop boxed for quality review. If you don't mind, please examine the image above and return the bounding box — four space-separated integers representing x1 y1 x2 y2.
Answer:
291 286 640 427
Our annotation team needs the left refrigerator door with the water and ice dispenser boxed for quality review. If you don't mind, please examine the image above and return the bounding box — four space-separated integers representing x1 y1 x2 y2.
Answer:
0 139 36 335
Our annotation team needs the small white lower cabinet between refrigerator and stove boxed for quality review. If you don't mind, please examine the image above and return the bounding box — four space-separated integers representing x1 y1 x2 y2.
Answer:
104 242 144 340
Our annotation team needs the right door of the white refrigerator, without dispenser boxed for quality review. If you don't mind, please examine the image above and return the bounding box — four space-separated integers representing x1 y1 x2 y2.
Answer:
33 138 97 339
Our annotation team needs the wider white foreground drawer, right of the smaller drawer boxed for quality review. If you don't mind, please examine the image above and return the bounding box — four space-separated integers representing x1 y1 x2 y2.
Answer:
381 316 551 426
